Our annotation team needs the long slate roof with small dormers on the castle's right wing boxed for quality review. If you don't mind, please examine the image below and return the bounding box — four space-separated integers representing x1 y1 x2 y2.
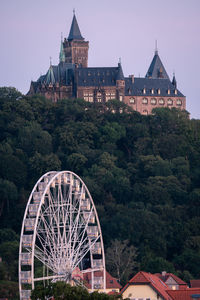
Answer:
125 77 184 97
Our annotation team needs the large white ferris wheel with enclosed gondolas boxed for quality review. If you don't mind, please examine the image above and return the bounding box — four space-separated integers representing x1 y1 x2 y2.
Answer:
19 171 106 300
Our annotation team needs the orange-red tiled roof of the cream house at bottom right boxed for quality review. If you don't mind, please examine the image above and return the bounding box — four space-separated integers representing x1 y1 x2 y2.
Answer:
121 271 171 300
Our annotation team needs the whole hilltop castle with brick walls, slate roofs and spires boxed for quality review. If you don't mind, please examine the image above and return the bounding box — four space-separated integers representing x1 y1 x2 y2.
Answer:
28 13 186 115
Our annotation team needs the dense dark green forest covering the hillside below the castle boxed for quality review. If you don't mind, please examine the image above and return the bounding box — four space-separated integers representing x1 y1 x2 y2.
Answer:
0 87 200 299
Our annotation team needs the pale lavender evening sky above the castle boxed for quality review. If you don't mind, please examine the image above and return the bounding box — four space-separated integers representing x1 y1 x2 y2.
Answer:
0 0 200 119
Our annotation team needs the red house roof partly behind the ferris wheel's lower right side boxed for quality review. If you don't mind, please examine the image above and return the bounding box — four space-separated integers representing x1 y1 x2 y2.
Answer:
83 271 122 289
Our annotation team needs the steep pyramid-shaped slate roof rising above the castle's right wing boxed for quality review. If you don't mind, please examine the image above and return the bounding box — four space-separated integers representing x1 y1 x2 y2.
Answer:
146 51 169 79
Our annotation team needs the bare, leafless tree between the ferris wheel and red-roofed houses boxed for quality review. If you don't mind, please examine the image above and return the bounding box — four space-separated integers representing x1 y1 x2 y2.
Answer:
106 240 137 284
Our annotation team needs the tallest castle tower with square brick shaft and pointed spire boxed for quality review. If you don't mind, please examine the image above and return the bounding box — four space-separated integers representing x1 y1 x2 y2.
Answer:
63 13 89 68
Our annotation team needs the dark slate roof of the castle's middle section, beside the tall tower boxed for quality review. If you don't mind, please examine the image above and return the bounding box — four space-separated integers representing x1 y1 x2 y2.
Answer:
76 67 119 87
